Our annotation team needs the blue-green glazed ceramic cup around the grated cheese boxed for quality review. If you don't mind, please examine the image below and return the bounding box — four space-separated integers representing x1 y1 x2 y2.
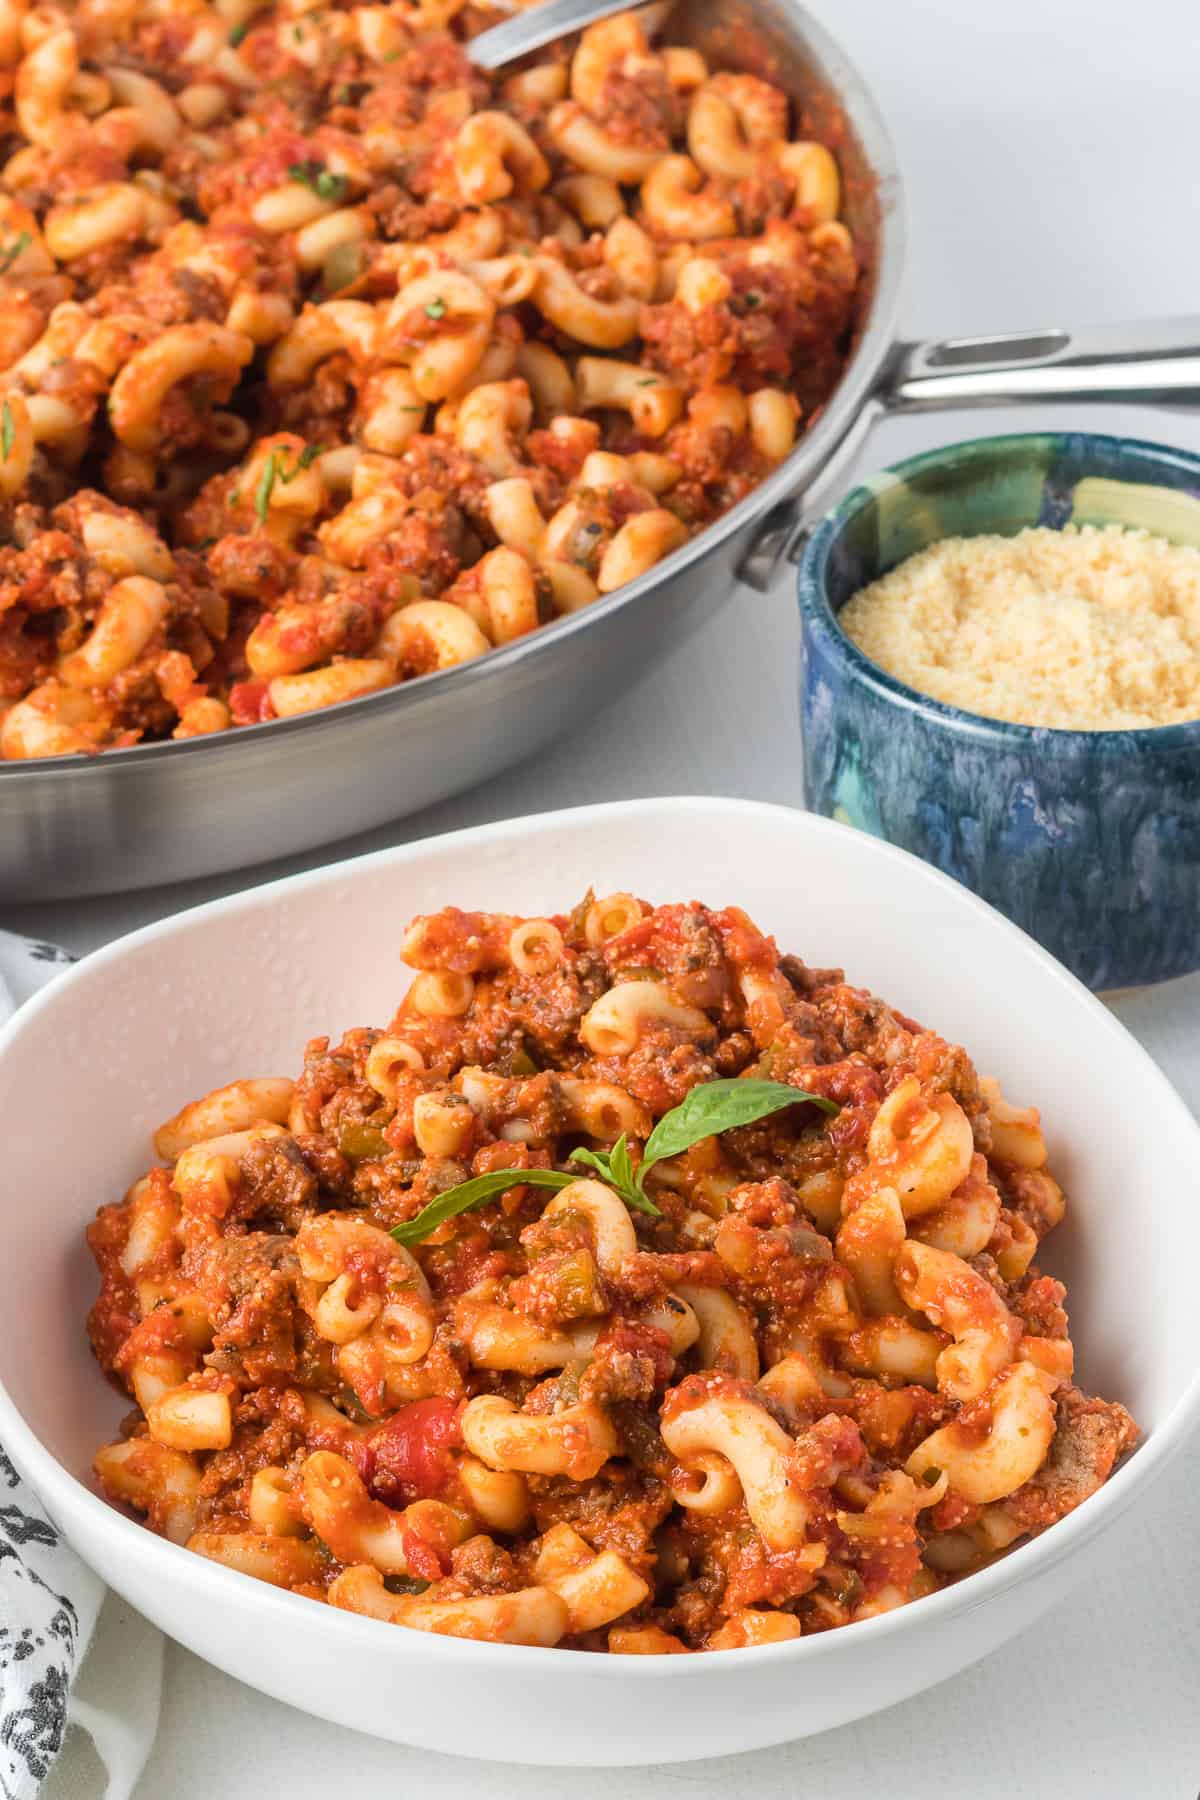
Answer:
799 432 1200 988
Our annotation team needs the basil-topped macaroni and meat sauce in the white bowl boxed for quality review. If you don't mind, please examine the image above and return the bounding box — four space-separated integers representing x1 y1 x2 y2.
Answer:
88 893 1137 1656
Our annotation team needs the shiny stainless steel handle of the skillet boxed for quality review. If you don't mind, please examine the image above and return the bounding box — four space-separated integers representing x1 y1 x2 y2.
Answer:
738 313 1200 592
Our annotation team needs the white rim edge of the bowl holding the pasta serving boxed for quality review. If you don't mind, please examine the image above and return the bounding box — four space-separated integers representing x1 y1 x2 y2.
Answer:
0 794 1200 1681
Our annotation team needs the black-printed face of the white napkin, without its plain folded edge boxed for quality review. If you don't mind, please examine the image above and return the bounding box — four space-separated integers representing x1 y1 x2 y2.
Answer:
0 932 113 1800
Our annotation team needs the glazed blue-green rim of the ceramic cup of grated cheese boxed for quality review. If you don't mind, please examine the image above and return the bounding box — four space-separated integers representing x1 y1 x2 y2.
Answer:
797 430 1200 756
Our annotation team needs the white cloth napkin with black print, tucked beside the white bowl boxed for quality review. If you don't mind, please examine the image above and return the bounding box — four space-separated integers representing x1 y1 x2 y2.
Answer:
0 931 162 1800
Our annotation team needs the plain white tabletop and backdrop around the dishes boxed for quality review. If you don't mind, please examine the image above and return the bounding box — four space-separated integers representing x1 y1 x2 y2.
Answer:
16 0 1200 1800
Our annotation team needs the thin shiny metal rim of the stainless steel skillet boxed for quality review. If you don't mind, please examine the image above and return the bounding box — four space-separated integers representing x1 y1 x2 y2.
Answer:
0 0 909 783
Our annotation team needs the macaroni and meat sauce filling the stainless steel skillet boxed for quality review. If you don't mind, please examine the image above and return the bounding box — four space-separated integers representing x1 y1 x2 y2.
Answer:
0 0 858 758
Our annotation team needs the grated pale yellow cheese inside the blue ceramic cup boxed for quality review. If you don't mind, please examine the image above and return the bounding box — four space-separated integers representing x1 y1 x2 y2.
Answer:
838 526 1200 731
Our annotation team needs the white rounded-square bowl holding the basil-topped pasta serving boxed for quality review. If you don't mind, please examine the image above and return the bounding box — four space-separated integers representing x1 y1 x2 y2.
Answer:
0 799 1200 1764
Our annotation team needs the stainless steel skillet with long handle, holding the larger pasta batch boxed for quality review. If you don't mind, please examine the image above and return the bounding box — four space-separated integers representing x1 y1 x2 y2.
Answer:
0 0 1200 900
